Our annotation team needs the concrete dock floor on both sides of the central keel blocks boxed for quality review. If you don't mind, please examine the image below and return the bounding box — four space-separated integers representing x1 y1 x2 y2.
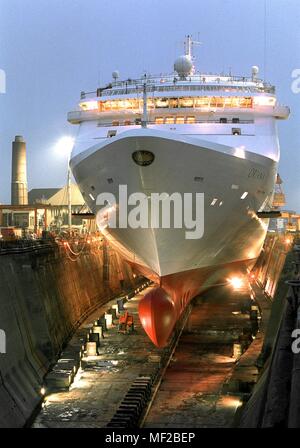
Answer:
33 287 268 428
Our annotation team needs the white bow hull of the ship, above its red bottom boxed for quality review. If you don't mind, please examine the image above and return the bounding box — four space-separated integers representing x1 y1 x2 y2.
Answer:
71 129 277 277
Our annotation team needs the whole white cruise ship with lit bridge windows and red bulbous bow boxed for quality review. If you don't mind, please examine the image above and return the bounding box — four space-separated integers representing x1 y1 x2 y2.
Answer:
68 36 289 347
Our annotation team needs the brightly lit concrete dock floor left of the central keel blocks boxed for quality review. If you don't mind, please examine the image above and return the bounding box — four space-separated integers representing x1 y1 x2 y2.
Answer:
33 289 164 428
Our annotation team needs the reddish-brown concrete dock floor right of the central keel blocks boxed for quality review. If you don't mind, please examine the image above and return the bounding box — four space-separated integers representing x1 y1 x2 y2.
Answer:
144 287 256 428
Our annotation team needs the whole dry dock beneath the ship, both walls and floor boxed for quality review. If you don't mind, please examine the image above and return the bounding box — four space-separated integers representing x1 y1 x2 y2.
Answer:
0 231 299 428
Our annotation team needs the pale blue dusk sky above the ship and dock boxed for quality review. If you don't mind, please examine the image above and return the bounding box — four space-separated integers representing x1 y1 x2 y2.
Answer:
0 0 300 212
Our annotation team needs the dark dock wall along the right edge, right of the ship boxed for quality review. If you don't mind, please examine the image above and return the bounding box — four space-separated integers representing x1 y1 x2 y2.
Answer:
239 234 300 428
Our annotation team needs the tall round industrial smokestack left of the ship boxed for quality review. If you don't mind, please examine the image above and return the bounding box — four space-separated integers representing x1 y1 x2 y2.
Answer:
11 135 28 205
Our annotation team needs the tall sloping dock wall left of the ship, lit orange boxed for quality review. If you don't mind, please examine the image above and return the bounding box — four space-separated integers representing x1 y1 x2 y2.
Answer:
0 238 136 427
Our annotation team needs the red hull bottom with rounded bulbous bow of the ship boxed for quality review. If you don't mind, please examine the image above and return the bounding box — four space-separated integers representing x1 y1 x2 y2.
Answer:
135 260 256 347
